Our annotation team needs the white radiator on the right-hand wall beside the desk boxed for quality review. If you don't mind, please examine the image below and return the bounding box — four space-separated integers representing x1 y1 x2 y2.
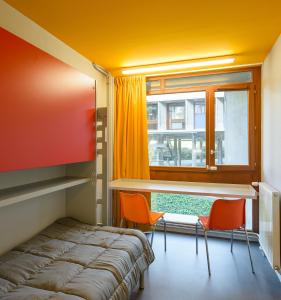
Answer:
259 182 280 271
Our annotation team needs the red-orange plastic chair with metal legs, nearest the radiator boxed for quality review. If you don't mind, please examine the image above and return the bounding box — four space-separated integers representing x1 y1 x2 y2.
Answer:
196 199 255 276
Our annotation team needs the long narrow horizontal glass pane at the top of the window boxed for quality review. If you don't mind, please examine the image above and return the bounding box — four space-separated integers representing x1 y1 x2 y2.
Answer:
165 71 252 89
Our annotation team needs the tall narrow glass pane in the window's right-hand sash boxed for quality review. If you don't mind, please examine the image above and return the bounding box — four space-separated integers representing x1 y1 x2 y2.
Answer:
215 90 249 165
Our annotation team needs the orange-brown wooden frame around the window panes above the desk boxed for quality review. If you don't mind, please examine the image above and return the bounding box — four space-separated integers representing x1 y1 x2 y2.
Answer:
147 67 260 173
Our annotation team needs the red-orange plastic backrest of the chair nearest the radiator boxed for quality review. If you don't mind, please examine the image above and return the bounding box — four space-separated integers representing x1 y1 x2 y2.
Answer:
208 199 246 230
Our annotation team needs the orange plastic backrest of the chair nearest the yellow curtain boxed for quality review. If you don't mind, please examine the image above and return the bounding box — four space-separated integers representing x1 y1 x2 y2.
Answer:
120 192 150 224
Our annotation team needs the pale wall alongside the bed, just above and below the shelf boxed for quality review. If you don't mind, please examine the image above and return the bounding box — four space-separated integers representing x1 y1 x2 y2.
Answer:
0 167 66 254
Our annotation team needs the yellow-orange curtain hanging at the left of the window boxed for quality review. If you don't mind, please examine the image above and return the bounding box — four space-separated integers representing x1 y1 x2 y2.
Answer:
113 76 150 226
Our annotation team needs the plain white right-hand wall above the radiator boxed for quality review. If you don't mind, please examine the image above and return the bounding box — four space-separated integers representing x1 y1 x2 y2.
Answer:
262 35 281 192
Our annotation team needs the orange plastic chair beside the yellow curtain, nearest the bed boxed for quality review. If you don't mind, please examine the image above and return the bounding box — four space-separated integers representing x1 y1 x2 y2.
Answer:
120 192 166 251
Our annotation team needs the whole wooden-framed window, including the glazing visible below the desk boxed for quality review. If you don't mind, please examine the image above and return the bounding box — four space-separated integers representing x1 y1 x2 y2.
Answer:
147 67 261 231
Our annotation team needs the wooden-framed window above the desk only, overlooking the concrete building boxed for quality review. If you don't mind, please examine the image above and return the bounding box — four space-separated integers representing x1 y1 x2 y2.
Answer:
147 71 255 171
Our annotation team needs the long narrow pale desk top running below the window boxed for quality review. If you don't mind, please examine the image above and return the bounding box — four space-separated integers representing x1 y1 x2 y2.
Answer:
109 179 257 199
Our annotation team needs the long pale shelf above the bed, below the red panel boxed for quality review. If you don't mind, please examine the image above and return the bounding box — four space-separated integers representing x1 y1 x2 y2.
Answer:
0 177 91 207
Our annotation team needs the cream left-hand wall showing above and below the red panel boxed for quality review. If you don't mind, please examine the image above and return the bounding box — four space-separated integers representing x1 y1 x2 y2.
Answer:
0 0 106 254
